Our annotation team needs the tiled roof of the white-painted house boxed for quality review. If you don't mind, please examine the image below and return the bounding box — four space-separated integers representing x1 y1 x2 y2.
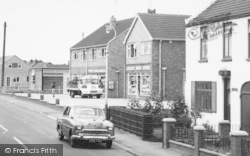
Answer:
187 0 250 26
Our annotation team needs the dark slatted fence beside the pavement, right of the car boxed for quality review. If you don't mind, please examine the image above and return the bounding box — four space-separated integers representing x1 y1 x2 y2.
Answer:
109 106 153 139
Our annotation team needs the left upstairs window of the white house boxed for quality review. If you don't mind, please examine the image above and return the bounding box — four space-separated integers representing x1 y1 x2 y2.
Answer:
200 27 208 61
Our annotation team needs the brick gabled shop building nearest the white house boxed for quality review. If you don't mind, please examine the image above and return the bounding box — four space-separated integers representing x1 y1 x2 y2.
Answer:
124 10 189 100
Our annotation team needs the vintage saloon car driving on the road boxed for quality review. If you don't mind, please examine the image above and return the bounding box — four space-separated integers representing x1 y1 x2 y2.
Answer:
56 105 115 148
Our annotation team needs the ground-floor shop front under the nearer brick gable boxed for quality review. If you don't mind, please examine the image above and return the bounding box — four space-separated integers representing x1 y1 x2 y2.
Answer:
126 65 151 97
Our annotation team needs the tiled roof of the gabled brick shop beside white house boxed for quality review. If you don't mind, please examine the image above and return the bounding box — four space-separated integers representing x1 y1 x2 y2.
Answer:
125 13 190 42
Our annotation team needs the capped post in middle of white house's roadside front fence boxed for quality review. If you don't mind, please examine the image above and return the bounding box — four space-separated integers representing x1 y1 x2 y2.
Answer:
194 126 205 156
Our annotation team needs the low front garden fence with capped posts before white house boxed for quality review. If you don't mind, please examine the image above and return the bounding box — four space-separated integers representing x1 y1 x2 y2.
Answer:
163 118 250 156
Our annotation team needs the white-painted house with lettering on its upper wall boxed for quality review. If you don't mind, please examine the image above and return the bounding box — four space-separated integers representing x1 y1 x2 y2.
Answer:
185 0 250 129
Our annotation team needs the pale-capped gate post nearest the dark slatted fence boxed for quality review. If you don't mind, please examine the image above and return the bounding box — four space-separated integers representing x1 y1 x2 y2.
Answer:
162 118 176 148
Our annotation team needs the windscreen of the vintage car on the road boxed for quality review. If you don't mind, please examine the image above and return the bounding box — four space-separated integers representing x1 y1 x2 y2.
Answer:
74 107 104 117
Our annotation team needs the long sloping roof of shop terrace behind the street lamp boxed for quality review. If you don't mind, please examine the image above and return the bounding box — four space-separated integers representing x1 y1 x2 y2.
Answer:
71 18 133 49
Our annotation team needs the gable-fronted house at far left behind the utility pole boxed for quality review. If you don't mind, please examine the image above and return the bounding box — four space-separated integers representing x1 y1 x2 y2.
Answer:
0 55 29 92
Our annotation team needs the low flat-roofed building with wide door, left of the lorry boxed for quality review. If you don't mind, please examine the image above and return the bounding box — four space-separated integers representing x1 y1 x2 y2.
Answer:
29 62 69 94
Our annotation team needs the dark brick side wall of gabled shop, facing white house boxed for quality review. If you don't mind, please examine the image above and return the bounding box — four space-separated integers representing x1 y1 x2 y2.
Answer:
151 41 185 100
